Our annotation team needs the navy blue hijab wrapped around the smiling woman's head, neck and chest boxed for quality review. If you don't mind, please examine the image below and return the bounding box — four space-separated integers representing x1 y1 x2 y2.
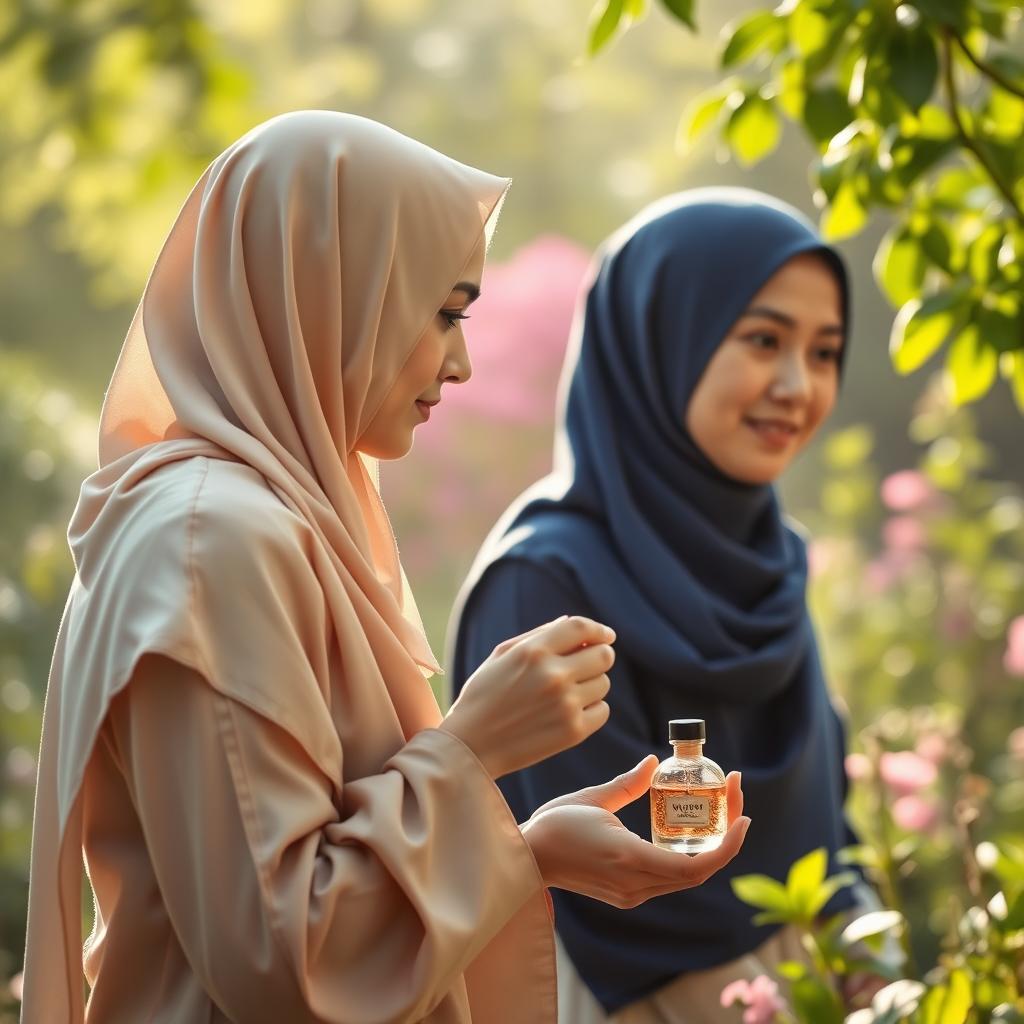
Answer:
471 187 849 703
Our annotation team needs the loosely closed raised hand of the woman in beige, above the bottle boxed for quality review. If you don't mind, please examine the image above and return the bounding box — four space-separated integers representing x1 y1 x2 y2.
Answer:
439 615 615 778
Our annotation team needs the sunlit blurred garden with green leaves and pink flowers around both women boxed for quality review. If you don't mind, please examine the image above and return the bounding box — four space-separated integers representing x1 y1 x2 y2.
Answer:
0 0 1024 1024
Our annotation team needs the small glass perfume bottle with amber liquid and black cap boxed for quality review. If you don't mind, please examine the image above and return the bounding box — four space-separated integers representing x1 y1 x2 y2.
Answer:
650 718 729 856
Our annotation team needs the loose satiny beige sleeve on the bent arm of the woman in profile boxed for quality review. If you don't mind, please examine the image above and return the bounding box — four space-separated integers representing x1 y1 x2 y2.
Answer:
110 655 542 1024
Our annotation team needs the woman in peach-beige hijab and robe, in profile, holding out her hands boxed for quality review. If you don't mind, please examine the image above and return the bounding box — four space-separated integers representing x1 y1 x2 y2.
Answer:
24 112 748 1024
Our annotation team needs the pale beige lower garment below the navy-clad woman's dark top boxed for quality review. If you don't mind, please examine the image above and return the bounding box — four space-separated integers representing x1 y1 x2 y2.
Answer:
556 925 807 1024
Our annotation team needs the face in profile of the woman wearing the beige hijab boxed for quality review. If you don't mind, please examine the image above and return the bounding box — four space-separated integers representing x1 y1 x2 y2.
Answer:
355 234 486 459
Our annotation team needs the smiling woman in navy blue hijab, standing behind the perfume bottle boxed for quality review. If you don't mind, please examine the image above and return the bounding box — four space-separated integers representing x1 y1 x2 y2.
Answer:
451 188 880 1024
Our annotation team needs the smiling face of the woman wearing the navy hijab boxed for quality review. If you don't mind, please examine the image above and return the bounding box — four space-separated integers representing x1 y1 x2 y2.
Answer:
686 253 843 483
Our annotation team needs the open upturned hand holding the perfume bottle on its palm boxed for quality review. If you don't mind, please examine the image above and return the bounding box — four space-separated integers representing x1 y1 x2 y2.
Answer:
522 755 751 909
